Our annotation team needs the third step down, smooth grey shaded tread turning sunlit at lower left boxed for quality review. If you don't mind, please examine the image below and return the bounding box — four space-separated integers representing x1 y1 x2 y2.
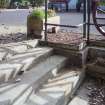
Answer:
0 56 66 104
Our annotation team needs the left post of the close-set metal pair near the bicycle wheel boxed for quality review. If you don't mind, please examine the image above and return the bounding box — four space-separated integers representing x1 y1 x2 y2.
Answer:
83 0 86 38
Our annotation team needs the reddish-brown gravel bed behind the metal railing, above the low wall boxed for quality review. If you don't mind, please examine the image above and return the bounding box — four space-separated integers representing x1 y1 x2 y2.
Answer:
47 30 105 44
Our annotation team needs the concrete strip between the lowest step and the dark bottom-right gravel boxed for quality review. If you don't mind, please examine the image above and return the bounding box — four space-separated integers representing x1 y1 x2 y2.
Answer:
67 78 90 105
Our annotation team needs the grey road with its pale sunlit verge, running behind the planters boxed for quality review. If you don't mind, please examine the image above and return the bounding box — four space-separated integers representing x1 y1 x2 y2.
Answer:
0 9 102 34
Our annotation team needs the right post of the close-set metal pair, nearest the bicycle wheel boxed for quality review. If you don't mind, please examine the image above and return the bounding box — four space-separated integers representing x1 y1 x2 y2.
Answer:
87 0 91 44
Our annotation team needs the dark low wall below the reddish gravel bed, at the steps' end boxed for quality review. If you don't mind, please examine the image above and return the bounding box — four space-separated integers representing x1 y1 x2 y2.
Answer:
39 41 88 67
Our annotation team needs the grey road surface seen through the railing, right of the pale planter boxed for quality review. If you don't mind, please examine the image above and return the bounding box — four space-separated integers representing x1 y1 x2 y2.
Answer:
58 13 99 35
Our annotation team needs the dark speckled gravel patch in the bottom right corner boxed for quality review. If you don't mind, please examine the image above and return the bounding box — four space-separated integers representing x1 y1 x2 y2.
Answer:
88 79 105 105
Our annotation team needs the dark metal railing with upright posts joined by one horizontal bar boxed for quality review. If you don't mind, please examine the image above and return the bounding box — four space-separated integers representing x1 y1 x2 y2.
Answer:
44 0 91 44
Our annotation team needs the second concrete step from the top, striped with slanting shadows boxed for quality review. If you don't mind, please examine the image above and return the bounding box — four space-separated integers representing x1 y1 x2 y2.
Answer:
0 48 53 83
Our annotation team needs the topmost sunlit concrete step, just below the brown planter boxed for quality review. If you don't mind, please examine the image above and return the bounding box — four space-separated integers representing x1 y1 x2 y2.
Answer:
0 40 39 61
